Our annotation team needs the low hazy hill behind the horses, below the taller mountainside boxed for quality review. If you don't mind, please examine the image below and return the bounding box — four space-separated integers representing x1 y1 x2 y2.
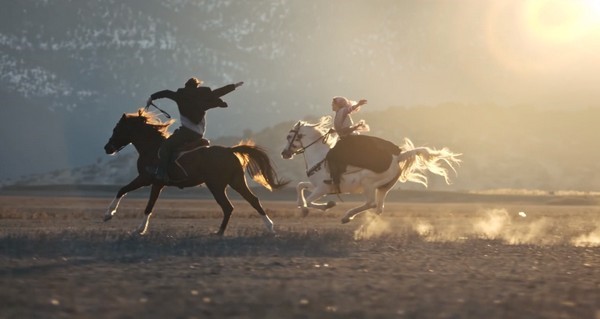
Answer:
12 104 600 191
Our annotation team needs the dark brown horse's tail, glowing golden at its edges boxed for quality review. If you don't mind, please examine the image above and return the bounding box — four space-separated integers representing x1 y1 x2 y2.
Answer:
231 141 289 190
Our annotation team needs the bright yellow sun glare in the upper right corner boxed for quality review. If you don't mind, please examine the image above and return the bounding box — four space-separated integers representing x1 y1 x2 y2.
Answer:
485 0 600 74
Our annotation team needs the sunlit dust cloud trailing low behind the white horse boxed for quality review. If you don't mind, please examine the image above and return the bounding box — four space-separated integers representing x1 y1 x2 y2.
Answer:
354 208 600 247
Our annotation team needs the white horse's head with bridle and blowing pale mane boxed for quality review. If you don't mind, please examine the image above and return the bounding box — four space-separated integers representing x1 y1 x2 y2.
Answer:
281 116 332 159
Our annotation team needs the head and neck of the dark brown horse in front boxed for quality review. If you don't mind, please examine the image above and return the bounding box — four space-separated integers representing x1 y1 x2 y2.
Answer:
104 109 172 154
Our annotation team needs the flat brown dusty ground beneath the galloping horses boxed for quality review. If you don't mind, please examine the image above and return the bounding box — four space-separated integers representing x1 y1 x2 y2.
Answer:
0 196 600 319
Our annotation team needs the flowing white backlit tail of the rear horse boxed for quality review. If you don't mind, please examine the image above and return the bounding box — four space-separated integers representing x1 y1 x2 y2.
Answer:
398 138 462 187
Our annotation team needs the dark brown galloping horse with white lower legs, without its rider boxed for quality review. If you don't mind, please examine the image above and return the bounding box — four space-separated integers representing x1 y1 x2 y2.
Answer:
104 109 288 235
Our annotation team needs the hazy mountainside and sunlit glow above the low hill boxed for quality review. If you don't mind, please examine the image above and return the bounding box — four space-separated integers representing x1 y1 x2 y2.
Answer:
0 0 600 182
